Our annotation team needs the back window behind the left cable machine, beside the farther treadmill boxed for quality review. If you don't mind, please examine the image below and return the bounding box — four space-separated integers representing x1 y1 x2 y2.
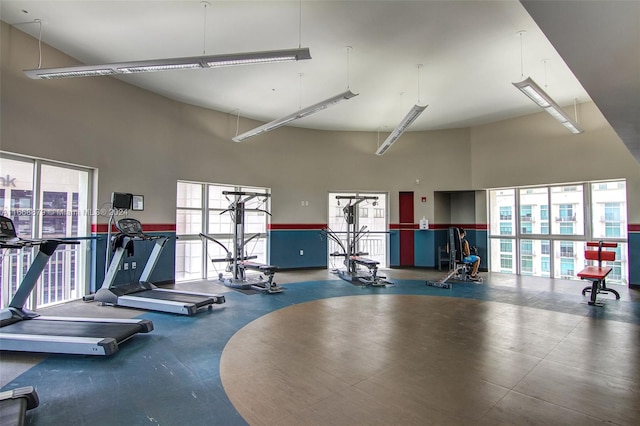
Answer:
176 181 270 281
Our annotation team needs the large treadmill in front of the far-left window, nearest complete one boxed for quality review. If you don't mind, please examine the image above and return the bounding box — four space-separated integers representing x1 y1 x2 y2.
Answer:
0 216 153 356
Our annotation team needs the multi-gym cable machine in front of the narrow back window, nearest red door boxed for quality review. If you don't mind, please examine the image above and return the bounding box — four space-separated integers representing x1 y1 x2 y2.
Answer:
323 195 395 287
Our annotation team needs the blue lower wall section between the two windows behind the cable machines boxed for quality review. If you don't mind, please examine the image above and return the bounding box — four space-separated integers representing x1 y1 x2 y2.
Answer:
269 229 329 269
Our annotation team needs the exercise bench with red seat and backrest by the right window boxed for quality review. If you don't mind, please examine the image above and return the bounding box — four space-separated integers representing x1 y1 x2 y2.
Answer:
577 241 620 306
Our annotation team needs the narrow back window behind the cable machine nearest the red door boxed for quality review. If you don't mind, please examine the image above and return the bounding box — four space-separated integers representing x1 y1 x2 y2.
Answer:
328 192 389 268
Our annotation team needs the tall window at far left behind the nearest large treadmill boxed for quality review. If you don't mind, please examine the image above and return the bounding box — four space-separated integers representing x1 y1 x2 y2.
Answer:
0 154 92 309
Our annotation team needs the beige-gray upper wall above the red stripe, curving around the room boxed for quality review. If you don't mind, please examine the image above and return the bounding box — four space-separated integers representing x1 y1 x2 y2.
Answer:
0 23 640 230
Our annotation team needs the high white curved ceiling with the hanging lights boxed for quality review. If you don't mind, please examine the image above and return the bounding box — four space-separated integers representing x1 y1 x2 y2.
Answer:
0 0 590 131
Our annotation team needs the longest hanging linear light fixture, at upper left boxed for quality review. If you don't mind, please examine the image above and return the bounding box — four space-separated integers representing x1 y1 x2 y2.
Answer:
24 47 311 80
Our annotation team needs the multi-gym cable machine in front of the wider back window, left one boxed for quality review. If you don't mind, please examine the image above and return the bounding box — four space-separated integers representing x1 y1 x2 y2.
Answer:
200 191 284 293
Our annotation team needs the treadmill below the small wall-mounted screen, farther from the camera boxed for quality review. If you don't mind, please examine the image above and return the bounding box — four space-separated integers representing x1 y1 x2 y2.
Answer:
93 217 225 316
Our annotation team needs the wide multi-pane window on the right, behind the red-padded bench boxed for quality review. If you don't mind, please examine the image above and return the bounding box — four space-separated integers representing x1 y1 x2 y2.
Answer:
489 181 628 285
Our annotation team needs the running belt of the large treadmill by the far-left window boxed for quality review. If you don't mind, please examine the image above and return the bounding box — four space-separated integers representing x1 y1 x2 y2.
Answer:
0 318 146 342
